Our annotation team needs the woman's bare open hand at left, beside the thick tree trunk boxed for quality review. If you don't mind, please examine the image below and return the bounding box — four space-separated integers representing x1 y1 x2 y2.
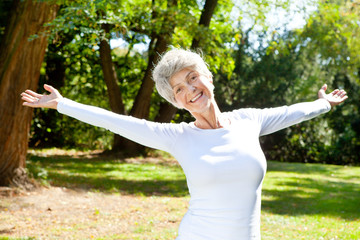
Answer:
21 84 63 109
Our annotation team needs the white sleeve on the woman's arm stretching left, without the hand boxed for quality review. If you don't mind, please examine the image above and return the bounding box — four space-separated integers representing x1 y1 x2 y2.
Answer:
57 98 181 152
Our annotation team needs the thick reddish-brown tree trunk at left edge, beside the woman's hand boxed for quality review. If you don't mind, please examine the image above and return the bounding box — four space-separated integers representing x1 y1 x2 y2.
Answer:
0 0 58 188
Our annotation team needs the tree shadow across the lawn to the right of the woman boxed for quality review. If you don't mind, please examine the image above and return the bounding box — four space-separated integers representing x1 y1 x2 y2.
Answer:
262 163 360 221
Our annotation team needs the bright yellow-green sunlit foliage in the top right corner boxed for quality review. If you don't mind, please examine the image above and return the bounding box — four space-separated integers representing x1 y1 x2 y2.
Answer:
302 0 360 69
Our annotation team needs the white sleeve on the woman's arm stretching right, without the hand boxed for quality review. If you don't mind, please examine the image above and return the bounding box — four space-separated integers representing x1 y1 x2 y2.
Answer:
232 99 331 136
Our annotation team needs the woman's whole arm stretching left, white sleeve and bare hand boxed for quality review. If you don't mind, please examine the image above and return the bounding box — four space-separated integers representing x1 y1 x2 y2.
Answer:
21 85 181 152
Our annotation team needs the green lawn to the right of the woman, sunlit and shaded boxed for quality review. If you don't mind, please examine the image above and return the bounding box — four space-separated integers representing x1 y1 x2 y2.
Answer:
262 162 360 240
